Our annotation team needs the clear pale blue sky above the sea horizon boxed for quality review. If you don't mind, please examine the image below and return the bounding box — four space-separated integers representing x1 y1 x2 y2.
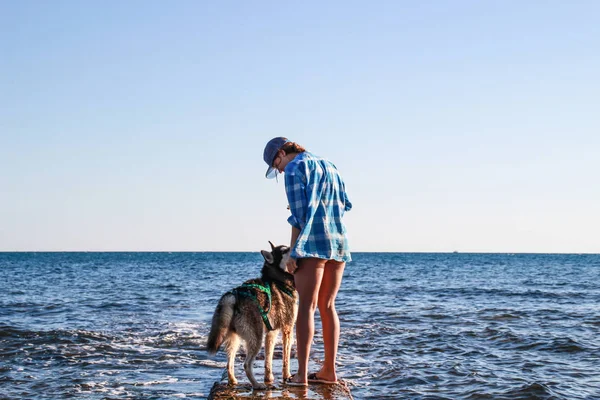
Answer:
0 0 600 253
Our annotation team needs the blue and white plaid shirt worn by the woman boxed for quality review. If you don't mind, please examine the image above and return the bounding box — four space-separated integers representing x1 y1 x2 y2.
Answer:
284 151 352 261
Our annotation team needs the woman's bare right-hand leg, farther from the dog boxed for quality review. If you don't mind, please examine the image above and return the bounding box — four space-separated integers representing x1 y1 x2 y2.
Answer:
317 260 346 381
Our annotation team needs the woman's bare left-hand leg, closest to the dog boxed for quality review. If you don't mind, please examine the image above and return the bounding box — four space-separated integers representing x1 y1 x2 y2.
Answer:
293 258 326 382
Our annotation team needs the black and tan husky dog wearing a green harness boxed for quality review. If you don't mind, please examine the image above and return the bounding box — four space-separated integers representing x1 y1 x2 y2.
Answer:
206 242 297 390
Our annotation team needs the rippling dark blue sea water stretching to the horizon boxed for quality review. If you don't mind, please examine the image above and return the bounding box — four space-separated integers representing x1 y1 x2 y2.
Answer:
0 252 600 399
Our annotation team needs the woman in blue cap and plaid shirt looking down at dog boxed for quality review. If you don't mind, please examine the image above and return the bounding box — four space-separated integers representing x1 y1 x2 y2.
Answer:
263 137 352 386
